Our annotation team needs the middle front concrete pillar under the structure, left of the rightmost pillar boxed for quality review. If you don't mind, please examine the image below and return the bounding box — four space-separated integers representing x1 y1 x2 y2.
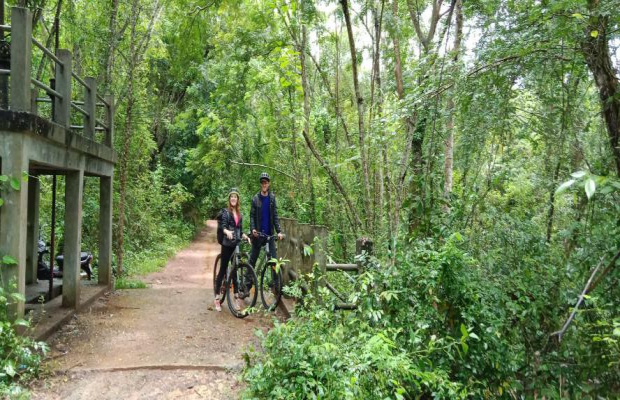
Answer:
62 170 84 308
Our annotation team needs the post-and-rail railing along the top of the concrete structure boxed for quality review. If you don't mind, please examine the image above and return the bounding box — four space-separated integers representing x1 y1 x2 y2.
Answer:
0 7 114 147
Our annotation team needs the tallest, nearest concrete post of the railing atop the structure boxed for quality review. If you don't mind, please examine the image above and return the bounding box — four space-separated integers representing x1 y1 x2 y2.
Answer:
10 7 32 112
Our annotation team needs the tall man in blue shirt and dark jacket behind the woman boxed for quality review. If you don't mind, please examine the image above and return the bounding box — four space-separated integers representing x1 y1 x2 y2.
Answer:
250 172 283 267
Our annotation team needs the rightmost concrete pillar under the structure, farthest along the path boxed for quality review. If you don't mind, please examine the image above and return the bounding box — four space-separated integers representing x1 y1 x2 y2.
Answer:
99 177 113 286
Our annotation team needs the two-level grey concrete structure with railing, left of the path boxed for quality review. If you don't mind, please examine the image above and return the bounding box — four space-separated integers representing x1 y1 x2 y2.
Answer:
0 7 117 317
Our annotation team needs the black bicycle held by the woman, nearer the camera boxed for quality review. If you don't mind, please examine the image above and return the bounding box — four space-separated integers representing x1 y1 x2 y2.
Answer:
213 238 258 318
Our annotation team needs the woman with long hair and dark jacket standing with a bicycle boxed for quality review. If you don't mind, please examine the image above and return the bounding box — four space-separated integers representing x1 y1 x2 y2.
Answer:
214 188 250 311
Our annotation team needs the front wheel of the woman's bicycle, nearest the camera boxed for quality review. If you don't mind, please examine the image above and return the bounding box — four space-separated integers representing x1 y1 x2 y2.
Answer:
226 263 258 318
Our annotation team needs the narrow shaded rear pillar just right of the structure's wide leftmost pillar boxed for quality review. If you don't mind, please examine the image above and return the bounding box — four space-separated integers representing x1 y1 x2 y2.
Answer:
26 176 41 285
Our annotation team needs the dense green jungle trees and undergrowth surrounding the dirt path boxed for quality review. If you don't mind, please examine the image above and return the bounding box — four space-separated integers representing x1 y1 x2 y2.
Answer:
1 0 620 399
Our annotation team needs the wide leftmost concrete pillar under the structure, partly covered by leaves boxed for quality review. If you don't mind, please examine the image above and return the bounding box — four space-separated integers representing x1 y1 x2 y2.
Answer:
0 134 28 319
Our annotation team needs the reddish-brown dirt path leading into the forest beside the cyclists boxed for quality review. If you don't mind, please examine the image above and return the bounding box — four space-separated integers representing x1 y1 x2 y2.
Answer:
32 221 270 399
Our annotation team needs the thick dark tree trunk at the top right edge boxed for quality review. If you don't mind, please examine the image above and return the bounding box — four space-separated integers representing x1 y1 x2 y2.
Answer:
581 0 620 175
